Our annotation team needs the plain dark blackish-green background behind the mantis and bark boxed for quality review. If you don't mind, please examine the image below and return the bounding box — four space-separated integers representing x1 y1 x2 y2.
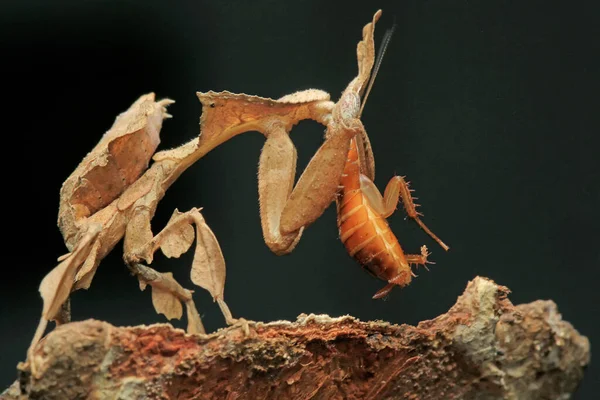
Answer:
0 0 600 399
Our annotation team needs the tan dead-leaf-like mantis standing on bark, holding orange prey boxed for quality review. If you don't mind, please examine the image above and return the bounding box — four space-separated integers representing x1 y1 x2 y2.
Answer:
28 11 448 368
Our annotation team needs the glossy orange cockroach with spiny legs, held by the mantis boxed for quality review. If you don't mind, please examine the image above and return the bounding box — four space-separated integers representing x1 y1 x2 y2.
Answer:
336 22 449 299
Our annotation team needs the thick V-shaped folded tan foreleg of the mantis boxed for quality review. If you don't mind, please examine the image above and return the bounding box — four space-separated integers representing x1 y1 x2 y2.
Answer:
258 119 363 254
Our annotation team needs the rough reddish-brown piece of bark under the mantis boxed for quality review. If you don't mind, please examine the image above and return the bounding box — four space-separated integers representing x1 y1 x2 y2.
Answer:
3 277 590 400
